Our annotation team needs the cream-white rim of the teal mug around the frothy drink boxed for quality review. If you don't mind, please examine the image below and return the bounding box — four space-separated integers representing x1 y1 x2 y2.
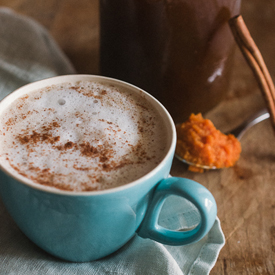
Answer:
0 74 176 196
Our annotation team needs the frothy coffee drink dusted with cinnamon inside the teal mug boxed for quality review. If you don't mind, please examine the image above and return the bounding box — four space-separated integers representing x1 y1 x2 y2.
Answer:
0 81 167 191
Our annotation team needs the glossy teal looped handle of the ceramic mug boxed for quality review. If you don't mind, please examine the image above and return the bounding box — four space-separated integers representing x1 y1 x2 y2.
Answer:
137 177 217 245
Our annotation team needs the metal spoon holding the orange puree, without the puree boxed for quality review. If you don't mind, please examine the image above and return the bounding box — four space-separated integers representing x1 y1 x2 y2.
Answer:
175 109 270 170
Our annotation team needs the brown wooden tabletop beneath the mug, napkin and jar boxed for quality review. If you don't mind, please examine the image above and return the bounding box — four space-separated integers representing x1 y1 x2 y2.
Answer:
0 0 275 275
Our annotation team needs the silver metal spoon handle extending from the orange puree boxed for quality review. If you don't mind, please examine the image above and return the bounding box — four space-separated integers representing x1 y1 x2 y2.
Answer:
229 108 270 140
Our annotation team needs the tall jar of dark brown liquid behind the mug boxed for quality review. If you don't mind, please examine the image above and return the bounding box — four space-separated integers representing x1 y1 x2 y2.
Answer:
100 0 241 123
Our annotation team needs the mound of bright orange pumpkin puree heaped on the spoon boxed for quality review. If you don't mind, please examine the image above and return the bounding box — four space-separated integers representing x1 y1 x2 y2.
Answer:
176 113 241 172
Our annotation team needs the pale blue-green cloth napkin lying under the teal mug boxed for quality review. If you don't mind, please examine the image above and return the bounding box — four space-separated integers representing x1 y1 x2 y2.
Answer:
0 8 225 275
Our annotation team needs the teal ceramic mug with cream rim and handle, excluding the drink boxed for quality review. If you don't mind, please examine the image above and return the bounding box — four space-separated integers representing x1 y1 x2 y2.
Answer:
0 75 217 262
